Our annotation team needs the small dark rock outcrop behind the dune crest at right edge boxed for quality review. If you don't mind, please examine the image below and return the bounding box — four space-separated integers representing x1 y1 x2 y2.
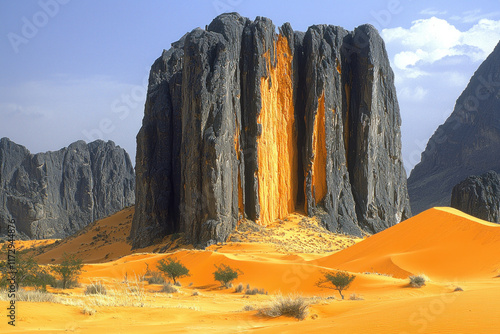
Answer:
451 171 500 224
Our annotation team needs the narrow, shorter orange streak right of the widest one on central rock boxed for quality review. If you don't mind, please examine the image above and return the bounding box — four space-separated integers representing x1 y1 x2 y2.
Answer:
312 93 326 203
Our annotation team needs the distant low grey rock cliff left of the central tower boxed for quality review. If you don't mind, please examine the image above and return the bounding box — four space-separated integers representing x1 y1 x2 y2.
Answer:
0 138 135 239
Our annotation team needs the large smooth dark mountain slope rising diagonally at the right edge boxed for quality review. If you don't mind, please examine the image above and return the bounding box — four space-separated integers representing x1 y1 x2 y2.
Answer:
408 43 500 214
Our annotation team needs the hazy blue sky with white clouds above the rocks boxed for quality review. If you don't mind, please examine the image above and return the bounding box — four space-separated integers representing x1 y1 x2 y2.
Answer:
0 0 500 176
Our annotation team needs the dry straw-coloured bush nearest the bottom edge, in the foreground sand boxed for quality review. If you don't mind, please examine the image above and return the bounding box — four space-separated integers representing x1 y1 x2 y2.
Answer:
259 295 309 320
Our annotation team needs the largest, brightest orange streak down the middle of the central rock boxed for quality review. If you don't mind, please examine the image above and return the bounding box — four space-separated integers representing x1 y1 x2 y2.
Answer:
257 35 298 225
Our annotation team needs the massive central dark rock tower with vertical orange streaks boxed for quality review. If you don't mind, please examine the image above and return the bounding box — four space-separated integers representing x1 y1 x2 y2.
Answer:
131 13 411 247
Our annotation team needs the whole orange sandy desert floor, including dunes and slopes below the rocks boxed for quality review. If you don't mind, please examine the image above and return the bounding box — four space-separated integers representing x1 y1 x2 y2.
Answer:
0 208 500 333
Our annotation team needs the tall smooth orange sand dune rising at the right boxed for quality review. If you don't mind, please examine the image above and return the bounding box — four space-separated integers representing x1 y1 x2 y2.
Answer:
318 208 500 281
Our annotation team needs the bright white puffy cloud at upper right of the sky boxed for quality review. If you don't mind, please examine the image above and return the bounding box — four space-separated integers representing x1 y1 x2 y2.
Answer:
382 17 500 77
